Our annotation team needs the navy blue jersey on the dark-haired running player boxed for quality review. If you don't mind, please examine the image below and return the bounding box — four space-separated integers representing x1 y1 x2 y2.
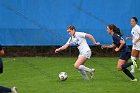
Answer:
112 34 130 52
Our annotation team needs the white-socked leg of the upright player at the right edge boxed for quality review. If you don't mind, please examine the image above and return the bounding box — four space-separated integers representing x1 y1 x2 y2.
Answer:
131 49 139 73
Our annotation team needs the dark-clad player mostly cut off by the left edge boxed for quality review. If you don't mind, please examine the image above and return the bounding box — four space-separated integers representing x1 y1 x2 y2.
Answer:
0 46 17 93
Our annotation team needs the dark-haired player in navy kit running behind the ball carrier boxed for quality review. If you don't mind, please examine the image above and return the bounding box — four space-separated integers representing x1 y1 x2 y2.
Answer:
102 24 137 81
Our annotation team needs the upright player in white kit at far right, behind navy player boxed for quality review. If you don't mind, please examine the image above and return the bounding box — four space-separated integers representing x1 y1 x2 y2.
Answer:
126 17 140 73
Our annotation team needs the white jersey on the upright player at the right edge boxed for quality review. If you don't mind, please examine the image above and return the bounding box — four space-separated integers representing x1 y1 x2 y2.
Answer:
131 25 140 45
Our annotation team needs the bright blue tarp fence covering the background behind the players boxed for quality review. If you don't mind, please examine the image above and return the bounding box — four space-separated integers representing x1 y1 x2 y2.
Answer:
0 0 140 46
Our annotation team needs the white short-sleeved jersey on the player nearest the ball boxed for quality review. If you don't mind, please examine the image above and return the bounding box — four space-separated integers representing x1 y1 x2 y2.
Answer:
66 32 90 53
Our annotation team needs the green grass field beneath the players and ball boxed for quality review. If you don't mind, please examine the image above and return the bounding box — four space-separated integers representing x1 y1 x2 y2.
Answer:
0 57 140 93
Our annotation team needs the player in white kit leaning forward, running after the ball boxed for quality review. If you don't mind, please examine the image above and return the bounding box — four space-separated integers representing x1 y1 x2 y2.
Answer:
55 26 100 80
